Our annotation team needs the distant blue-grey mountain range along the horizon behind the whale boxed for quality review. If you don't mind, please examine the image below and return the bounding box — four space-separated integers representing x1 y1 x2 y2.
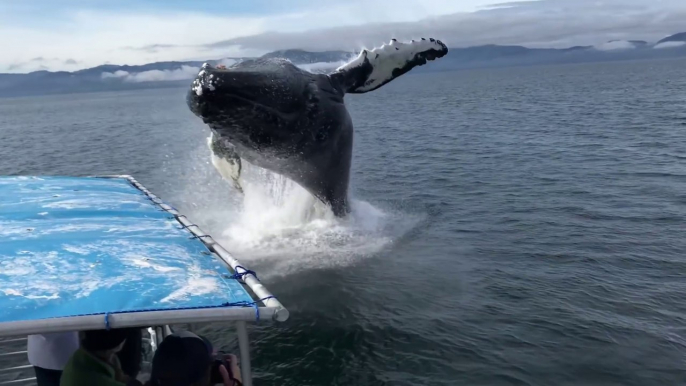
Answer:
0 32 686 97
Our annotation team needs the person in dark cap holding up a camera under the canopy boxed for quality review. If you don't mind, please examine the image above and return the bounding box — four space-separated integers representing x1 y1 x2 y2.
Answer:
146 331 242 386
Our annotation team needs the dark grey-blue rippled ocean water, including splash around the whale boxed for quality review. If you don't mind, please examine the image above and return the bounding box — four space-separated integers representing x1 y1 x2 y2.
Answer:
0 60 686 386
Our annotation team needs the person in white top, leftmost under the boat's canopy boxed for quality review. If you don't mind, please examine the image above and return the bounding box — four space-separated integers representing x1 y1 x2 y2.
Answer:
26 331 79 386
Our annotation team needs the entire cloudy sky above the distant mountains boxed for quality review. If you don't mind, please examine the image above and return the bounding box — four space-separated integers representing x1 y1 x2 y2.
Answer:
0 0 686 73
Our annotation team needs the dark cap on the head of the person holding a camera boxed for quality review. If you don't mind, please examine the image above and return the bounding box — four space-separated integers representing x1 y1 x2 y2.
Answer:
150 331 214 386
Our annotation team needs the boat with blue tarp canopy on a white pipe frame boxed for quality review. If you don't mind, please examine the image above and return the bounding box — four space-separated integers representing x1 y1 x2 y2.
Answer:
0 175 289 386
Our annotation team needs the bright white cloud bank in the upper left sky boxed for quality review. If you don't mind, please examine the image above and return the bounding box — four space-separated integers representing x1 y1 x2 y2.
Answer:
0 11 267 72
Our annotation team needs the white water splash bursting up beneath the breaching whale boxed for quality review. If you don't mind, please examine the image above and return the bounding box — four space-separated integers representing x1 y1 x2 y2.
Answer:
169 142 424 277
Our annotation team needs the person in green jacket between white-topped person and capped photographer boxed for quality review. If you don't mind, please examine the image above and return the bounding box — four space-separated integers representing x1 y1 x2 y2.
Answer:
60 328 141 386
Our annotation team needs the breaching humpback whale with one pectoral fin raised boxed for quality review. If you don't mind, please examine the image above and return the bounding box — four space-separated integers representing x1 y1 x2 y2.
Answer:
186 39 448 217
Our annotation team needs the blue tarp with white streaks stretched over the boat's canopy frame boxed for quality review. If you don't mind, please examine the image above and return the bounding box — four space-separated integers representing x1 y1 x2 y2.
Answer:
0 177 253 323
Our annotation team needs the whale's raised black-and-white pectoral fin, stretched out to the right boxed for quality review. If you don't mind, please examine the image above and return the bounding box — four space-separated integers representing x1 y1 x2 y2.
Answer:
330 38 448 94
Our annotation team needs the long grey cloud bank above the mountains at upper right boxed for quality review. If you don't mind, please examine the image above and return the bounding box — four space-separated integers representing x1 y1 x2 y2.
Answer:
212 0 686 51
